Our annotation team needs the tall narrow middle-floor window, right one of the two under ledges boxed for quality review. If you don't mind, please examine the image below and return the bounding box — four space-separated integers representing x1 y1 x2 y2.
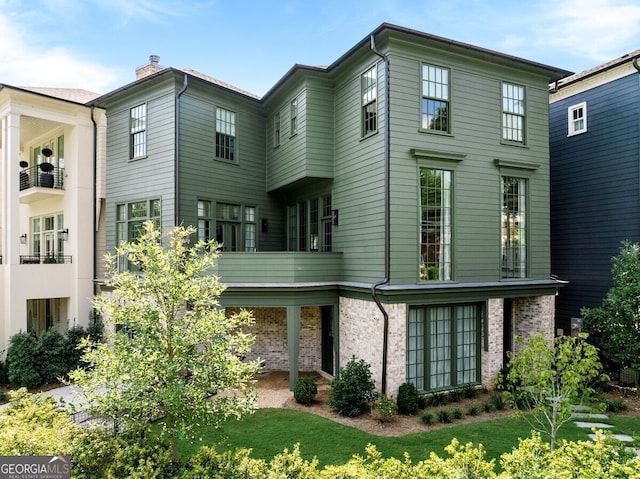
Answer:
501 176 527 278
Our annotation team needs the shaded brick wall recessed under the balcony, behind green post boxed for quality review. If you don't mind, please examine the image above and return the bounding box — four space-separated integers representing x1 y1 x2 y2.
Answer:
226 306 322 371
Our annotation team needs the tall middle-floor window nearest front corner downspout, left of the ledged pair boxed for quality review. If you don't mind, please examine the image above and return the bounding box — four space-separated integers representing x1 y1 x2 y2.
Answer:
420 168 452 281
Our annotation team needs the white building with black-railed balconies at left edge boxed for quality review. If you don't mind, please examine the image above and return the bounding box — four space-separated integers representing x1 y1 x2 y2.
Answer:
0 85 106 359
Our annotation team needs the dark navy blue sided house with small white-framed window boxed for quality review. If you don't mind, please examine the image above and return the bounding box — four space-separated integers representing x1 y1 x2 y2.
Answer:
549 50 640 333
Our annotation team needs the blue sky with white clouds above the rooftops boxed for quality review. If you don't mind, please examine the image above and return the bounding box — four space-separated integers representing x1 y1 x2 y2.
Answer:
0 0 640 95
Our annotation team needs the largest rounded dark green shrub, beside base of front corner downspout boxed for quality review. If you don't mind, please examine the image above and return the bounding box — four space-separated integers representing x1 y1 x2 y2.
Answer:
327 356 376 417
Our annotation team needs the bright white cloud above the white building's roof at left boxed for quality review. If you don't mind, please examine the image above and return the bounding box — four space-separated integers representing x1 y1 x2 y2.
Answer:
0 14 119 93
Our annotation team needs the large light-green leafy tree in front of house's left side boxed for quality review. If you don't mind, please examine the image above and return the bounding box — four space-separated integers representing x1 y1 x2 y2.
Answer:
70 222 259 458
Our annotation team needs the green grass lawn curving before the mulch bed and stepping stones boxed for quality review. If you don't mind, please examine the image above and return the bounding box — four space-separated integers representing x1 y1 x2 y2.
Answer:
180 409 640 467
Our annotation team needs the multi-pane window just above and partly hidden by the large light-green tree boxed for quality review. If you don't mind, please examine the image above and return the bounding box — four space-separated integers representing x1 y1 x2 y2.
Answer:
116 199 161 271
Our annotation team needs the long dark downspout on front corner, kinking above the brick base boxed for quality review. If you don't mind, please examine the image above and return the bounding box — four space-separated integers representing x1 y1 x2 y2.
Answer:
371 35 391 394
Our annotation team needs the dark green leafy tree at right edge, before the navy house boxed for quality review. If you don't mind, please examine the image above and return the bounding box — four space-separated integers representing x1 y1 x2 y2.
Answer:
581 241 640 376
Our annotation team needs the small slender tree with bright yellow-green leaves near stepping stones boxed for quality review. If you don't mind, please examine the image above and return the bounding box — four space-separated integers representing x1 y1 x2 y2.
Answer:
506 334 603 450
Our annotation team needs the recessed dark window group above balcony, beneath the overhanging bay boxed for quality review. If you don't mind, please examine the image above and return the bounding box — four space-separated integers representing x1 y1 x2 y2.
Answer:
287 195 333 252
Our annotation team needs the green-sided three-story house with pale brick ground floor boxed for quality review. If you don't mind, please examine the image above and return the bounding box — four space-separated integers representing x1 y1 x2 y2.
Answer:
94 24 569 395
